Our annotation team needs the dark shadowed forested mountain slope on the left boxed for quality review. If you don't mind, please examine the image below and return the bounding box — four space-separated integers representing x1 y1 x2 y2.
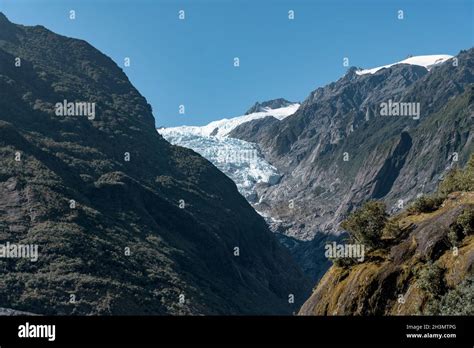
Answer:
0 14 308 314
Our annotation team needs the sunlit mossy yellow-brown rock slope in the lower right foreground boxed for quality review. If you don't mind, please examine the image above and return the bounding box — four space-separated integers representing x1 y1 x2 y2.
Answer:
299 192 474 315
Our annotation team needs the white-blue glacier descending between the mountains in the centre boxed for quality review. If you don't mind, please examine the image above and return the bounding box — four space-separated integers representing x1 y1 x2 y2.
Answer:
157 103 300 203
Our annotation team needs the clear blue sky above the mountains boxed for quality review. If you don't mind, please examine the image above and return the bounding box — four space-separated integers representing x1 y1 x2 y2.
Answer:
0 0 474 126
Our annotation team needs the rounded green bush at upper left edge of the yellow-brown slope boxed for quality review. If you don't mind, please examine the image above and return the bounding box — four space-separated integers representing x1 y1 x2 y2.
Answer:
341 201 388 248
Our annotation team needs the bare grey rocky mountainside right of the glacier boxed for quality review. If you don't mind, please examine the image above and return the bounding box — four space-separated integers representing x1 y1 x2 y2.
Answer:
231 49 474 240
